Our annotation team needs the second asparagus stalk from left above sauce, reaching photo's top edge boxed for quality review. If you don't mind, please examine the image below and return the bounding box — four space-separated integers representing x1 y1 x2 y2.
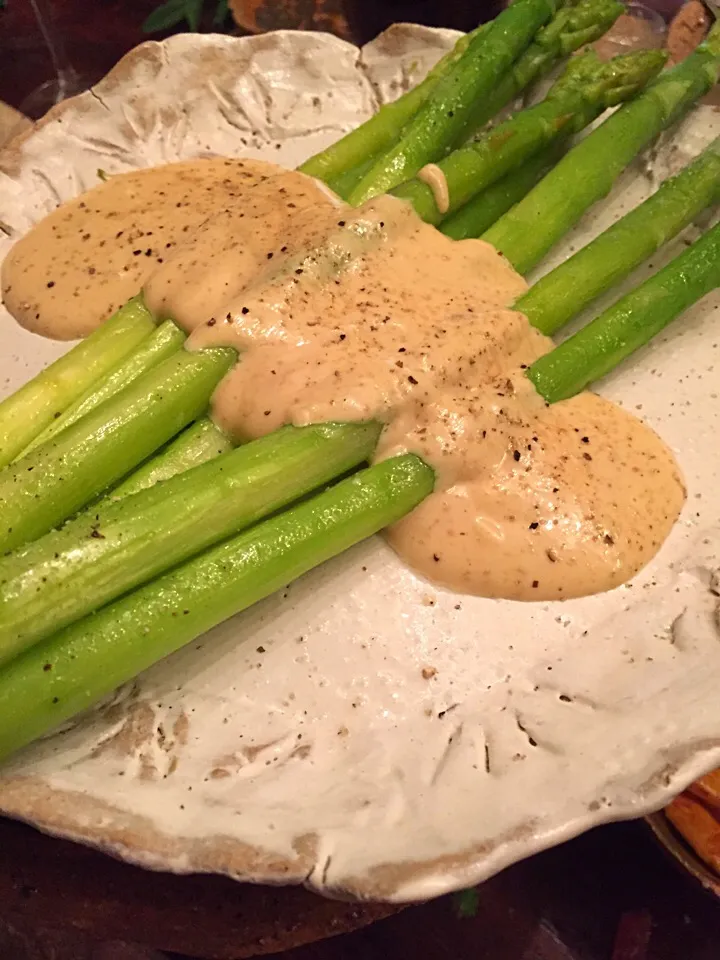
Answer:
350 0 554 205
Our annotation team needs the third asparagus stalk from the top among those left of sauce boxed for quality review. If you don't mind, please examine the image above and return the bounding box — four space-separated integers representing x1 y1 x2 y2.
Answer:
0 348 236 550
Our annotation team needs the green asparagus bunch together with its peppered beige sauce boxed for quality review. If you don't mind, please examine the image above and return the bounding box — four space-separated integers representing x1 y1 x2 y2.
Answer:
0 0 720 755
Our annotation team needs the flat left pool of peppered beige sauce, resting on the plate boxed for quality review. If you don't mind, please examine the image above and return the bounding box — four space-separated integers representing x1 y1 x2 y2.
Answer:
1 159 320 340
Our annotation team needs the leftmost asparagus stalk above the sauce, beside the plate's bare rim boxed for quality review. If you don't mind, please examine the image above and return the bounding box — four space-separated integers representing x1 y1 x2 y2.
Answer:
298 24 485 186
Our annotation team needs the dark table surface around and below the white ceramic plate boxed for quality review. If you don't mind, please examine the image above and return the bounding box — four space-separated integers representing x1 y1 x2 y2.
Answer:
0 0 720 960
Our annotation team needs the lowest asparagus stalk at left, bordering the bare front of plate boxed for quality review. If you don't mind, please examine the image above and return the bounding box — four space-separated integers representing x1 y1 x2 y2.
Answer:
0 454 434 758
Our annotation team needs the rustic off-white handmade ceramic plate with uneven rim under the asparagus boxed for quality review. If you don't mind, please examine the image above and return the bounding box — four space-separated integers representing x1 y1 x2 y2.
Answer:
0 27 720 901
